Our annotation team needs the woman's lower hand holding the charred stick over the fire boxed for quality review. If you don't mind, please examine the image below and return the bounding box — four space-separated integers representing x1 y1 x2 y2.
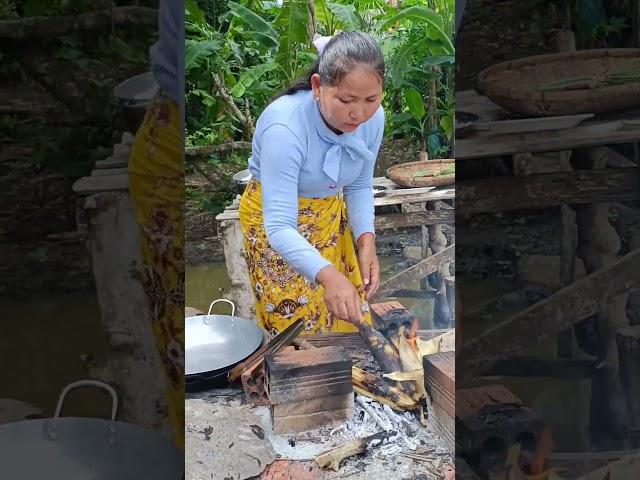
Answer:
316 265 364 324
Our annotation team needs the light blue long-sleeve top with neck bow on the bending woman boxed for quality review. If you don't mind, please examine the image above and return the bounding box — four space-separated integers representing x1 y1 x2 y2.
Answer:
249 90 384 282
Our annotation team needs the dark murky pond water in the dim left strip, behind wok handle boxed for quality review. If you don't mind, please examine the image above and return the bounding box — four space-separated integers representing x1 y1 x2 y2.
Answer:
0 293 109 417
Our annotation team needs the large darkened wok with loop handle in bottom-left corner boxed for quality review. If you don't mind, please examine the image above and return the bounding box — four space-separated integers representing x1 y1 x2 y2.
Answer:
0 380 184 480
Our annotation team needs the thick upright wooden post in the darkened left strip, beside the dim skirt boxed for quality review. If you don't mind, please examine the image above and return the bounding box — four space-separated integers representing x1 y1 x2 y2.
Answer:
84 191 170 436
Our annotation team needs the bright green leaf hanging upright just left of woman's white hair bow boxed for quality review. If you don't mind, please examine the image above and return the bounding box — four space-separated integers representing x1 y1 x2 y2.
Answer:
276 0 309 81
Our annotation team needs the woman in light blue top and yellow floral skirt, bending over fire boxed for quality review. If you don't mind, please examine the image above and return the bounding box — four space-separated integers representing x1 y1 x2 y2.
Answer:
240 32 384 334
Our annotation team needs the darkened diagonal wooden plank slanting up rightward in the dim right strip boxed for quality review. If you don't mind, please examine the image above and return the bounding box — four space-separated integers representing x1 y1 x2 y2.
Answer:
457 249 640 382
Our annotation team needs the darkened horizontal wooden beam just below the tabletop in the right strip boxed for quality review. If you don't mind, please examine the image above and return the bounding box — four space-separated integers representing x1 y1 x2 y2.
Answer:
456 167 640 215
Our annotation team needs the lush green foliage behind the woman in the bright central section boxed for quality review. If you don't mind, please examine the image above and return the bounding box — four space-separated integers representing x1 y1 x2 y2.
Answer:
185 0 455 215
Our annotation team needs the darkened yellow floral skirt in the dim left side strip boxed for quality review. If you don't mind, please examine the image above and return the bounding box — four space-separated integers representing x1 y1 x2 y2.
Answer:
129 95 184 448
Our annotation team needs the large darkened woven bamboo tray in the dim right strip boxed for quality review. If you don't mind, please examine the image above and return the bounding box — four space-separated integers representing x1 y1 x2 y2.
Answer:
478 48 640 116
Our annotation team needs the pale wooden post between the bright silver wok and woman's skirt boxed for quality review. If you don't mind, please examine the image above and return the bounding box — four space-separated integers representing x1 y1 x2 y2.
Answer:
218 220 256 319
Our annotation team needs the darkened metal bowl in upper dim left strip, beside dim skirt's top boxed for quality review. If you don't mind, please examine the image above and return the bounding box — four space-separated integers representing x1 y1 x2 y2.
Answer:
113 72 160 133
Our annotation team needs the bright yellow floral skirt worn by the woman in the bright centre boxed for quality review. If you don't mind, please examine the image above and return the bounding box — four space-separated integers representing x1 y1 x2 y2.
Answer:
240 180 371 335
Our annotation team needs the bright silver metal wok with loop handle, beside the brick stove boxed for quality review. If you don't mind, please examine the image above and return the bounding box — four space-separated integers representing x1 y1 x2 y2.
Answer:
184 298 264 391
